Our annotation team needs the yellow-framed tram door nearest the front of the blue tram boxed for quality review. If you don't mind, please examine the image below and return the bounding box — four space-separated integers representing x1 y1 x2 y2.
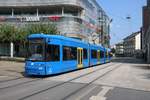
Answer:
77 48 83 68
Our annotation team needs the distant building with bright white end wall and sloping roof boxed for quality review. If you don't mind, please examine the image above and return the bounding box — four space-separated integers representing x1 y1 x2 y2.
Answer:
123 31 142 57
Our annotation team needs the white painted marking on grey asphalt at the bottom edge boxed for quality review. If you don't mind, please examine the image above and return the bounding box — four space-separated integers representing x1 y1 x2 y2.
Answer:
89 86 114 100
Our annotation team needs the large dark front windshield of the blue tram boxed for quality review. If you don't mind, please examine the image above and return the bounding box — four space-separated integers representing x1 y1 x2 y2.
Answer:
27 39 45 61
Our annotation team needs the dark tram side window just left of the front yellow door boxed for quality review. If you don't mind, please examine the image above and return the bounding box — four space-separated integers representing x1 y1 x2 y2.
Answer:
63 46 77 61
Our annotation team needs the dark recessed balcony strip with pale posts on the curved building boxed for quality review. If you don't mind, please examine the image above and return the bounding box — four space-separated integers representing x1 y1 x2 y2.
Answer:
0 6 82 17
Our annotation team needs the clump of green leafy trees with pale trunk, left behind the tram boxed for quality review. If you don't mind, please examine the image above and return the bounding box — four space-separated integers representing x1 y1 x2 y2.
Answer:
0 23 57 57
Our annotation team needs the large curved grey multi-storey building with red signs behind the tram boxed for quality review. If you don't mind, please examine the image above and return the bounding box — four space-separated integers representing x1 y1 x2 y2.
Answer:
0 0 110 56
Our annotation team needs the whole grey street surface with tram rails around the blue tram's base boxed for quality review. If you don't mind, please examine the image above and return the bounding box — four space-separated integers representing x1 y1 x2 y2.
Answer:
0 58 150 100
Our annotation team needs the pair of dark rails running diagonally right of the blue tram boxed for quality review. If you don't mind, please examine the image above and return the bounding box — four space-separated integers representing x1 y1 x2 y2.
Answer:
19 64 121 100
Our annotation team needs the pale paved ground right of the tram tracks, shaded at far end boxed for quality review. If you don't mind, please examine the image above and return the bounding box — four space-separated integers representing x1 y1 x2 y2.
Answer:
95 57 150 91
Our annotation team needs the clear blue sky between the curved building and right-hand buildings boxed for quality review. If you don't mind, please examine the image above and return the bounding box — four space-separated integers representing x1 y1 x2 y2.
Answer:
97 0 146 45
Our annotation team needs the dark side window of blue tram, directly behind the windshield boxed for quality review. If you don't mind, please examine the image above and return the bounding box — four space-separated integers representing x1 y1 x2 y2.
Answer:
46 45 60 61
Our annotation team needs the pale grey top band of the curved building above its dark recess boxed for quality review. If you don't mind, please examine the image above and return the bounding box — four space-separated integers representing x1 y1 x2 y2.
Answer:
0 0 80 7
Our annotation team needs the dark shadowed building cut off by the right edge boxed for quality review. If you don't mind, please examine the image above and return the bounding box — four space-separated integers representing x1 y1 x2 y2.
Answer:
142 0 150 63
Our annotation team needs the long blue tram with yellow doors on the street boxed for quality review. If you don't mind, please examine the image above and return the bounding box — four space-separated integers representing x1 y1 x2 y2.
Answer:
25 34 110 75
